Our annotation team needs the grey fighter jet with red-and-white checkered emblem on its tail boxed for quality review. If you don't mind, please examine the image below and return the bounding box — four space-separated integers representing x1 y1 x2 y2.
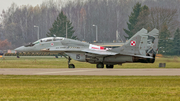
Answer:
15 28 159 68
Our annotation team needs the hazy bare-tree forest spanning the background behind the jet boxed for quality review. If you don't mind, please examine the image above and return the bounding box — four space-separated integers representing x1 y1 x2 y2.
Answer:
0 0 180 54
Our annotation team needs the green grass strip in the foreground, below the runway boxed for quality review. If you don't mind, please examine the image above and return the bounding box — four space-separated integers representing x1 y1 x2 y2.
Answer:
0 75 180 101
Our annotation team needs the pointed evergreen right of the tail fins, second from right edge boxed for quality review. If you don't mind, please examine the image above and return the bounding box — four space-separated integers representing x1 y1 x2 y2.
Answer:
159 24 173 55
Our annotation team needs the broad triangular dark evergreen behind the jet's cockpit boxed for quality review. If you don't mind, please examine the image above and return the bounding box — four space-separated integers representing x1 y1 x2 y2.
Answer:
46 11 76 39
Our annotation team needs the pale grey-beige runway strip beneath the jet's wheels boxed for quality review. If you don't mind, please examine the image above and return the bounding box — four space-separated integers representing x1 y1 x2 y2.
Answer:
0 68 180 76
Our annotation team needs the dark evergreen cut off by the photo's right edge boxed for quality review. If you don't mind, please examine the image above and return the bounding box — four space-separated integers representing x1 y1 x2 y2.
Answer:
173 28 180 55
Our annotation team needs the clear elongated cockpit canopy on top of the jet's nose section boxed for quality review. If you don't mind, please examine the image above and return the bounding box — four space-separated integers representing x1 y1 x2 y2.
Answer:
25 37 64 47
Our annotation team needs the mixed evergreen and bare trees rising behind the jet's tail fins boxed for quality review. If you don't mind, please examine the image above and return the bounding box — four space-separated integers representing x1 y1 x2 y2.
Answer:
124 2 180 55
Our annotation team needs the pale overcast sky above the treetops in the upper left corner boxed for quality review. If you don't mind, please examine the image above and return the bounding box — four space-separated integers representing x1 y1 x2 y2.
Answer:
0 0 46 14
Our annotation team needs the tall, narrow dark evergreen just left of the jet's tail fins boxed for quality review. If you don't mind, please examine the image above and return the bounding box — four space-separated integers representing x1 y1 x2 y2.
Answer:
123 2 141 38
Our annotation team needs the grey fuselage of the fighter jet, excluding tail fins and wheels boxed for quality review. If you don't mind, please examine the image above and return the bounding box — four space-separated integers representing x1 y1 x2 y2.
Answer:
15 34 156 65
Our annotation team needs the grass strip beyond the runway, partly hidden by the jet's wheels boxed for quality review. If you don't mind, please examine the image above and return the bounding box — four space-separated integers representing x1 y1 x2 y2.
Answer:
0 56 180 68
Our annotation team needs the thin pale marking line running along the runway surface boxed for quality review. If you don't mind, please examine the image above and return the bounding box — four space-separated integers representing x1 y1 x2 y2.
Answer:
35 69 98 75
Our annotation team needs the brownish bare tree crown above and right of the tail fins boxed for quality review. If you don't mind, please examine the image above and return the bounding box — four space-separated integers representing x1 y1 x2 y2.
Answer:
149 7 179 32
